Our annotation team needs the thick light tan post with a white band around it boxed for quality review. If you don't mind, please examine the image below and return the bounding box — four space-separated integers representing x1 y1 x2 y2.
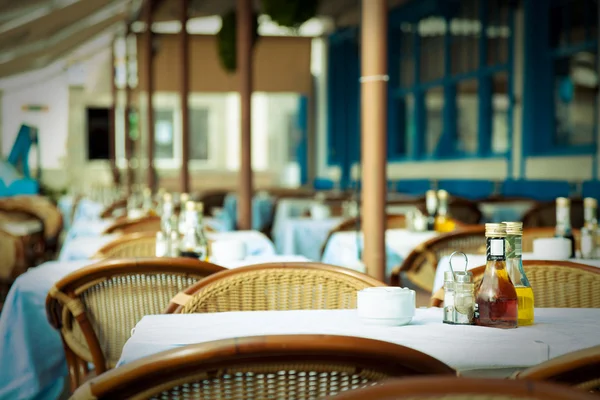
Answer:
361 0 388 281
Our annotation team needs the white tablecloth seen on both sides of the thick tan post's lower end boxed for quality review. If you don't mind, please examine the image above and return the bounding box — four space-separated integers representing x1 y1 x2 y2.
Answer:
322 229 438 276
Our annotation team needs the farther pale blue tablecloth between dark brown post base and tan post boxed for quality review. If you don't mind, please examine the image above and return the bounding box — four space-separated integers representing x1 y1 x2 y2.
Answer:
273 217 344 261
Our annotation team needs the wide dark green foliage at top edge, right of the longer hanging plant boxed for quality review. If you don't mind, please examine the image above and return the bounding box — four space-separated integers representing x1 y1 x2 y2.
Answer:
262 0 319 28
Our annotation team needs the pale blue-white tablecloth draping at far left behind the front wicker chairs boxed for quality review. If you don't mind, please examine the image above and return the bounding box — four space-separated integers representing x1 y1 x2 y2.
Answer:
0 255 307 400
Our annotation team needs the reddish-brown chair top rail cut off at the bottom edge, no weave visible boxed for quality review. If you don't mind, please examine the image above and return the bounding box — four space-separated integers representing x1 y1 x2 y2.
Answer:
331 376 598 400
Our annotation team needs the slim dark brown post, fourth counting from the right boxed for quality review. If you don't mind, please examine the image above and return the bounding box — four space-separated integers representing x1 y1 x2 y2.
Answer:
144 0 156 190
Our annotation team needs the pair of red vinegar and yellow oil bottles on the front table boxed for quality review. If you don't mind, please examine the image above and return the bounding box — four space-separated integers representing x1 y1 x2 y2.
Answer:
473 222 534 329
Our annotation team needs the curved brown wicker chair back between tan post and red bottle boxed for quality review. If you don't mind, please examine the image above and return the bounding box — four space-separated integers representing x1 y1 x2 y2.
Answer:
391 226 485 292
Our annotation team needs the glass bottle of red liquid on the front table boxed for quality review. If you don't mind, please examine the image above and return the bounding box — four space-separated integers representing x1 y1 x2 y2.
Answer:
475 224 519 329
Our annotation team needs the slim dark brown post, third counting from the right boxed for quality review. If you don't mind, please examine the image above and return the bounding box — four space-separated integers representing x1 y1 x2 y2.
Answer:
179 0 190 193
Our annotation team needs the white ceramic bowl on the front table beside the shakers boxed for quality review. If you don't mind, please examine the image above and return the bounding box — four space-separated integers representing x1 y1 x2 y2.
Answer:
356 286 416 326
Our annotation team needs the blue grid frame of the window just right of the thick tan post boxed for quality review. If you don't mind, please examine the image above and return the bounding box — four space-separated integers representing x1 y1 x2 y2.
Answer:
388 0 515 162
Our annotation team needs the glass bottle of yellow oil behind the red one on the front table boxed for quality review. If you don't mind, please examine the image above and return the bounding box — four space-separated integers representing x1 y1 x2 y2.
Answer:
505 222 534 326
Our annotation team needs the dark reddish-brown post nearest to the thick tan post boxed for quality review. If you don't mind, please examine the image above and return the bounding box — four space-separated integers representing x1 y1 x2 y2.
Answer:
236 0 253 230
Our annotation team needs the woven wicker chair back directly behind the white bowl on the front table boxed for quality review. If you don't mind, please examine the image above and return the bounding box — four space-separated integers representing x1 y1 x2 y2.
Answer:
167 262 385 314
